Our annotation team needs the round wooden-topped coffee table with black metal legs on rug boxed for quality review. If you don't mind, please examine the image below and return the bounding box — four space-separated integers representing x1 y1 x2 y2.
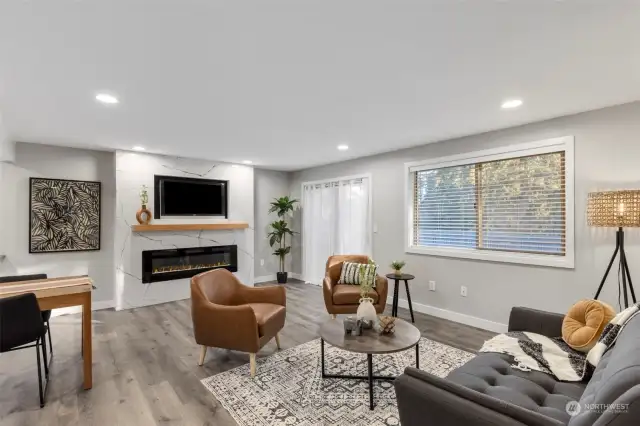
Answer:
320 318 420 410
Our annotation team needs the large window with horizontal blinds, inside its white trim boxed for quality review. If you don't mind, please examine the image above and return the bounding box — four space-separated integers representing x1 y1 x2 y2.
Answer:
412 151 566 256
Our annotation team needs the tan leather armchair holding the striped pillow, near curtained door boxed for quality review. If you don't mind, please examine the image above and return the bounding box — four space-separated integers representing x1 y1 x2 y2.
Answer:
322 255 388 317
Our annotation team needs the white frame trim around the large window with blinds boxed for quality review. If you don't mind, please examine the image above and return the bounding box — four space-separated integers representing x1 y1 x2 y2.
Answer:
404 136 575 269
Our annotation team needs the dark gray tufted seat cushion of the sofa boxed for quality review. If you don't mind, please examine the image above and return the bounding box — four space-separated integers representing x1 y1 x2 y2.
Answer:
447 353 587 424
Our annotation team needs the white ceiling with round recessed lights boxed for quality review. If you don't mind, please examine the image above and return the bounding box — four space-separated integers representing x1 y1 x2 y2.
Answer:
0 0 640 170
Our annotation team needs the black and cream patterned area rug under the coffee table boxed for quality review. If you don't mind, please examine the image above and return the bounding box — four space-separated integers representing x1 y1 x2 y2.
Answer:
202 338 475 426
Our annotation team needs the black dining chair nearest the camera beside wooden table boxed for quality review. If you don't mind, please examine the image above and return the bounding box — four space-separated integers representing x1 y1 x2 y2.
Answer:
0 293 49 408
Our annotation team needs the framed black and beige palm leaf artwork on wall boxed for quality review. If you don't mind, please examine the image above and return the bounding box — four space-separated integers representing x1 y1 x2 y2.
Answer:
29 178 101 253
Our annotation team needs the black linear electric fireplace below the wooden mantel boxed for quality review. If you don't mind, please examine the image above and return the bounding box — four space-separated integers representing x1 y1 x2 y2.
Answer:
142 245 238 283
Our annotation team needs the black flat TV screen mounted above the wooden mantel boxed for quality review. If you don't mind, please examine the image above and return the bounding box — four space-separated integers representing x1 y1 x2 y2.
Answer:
155 175 228 219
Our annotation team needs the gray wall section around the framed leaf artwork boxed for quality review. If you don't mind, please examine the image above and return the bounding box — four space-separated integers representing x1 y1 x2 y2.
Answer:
0 143 115 302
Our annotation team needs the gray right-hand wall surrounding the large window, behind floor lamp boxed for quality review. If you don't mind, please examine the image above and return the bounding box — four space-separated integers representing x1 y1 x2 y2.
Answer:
291 102 640 324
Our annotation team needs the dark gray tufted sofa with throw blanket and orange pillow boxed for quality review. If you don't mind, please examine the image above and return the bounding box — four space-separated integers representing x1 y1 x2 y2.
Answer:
394 308 640 426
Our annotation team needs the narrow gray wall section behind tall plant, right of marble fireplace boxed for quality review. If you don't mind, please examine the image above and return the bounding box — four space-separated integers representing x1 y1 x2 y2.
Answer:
254 169 291 280
